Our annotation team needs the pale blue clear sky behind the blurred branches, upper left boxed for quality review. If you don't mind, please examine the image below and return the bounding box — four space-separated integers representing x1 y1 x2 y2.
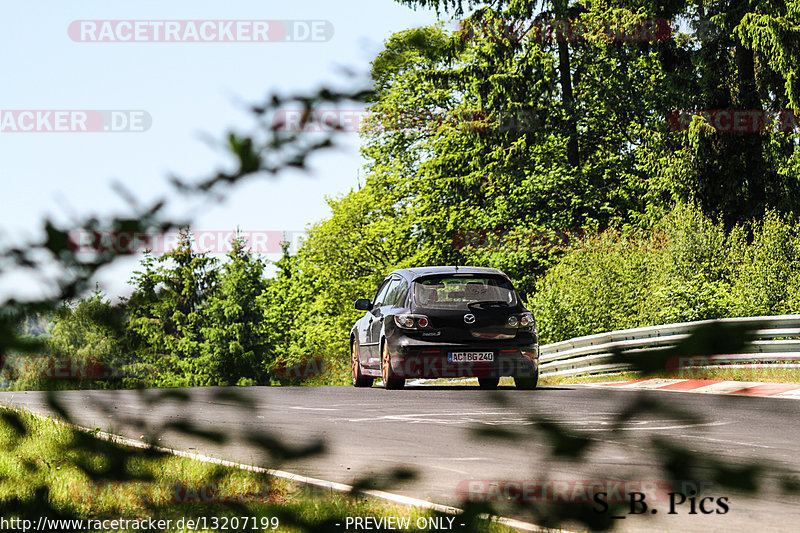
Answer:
0 0 446 298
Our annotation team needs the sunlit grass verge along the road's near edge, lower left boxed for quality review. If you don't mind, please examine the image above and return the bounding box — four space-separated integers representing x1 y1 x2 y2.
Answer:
0 408 515 532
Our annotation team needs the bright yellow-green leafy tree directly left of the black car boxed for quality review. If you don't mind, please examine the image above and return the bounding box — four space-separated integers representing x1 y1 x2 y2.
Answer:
262 186 414 380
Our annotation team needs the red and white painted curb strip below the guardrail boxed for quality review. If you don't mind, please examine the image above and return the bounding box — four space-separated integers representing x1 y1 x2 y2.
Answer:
593 378 800 400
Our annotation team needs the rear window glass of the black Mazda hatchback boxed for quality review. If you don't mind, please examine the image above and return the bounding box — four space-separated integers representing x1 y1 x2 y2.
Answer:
414 275 518 309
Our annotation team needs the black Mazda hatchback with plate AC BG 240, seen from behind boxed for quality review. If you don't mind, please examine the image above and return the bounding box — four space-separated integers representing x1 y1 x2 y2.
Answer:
350 266 539 389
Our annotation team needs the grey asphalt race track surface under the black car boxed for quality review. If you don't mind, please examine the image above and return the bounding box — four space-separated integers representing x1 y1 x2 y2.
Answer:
0 386 800 531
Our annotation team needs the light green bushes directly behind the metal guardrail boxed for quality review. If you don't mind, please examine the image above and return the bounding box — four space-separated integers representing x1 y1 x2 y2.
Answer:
532 205 800 343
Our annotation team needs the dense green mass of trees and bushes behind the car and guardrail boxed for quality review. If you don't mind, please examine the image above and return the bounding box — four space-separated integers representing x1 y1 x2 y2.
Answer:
248 0 800 382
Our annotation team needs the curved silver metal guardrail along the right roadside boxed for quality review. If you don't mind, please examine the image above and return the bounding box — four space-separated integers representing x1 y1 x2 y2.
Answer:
539 315 800 376
